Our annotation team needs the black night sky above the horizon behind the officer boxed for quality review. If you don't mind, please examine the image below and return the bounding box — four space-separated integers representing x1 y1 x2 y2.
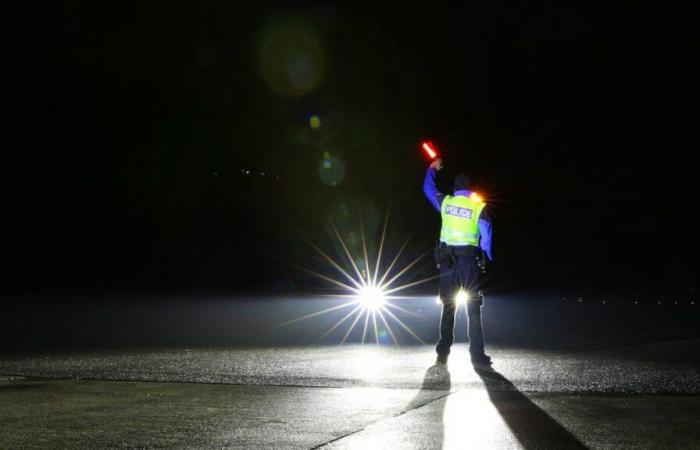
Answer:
0 1 700 293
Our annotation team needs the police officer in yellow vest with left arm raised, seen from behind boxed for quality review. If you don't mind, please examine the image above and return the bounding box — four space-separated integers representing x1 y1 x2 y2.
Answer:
423 159 493 365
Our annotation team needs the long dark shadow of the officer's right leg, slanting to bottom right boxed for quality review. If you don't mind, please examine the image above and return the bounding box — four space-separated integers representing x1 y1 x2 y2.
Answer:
474 367 587 449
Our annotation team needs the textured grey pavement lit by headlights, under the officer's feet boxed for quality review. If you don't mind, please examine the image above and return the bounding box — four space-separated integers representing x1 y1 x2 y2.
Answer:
0 340 700 449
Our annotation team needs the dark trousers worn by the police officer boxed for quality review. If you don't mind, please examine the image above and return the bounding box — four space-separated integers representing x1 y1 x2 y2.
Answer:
436 252 484 357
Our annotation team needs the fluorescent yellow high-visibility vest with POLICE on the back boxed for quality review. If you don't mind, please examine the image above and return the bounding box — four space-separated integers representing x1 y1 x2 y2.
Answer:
440 195 486 246
